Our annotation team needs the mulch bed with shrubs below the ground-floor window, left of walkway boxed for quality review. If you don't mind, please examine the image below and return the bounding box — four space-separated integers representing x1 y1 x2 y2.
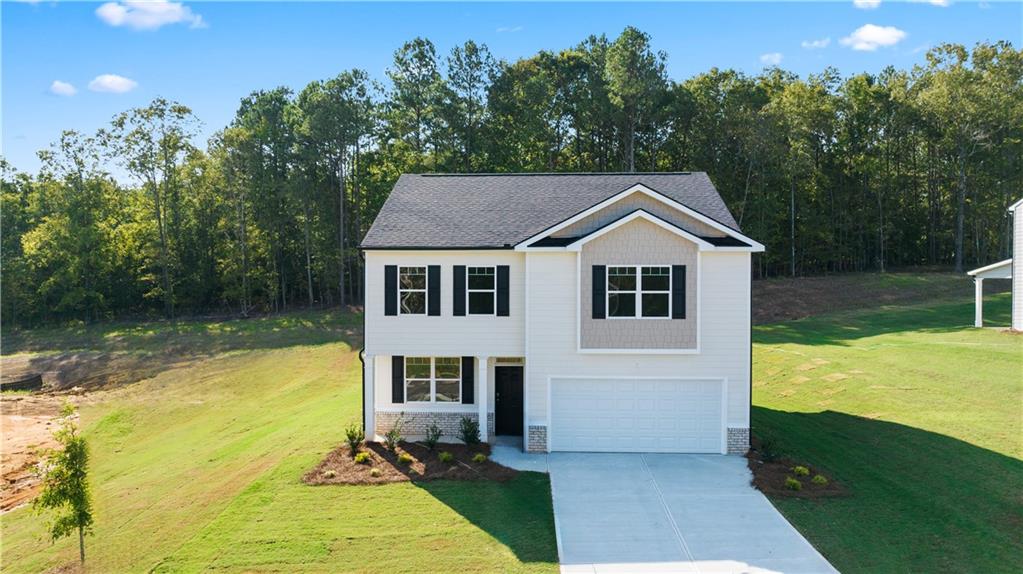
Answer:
302 442 511 484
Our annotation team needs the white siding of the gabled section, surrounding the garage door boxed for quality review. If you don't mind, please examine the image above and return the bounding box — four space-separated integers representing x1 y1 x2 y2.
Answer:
526 252 751 428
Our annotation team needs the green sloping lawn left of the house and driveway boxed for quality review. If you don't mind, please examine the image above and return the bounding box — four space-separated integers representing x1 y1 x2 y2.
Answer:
0 313 557 572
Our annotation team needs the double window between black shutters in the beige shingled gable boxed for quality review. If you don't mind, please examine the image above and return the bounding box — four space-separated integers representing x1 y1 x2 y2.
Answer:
608 265 671 319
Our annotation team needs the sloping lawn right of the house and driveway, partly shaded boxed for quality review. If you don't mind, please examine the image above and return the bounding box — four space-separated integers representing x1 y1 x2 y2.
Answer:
753 295 1023 572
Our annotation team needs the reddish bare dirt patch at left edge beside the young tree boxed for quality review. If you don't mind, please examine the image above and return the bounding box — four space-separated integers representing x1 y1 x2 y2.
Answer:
0 395 62 512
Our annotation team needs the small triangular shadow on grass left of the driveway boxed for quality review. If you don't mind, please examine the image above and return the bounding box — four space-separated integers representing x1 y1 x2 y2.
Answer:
413 473 558 565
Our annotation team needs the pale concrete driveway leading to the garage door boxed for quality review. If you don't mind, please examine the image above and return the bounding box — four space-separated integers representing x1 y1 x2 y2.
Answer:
547 453 837 574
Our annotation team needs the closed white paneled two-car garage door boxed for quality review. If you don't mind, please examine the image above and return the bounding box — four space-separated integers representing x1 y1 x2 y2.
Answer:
549 378 724 452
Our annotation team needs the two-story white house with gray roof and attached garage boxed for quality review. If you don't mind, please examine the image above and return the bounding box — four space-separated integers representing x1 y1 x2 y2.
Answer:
361 172 764 453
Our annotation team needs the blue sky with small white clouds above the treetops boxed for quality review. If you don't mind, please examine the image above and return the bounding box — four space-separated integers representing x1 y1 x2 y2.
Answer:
0 0 1023 171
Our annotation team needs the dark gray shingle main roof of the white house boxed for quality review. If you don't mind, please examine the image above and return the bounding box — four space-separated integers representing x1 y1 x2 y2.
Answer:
361 172 739 249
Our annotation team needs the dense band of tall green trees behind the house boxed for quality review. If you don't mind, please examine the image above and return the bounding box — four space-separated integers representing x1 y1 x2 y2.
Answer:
0 28 1023 325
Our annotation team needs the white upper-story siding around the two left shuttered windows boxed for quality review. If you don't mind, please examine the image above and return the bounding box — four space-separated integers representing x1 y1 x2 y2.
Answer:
365 250 525 356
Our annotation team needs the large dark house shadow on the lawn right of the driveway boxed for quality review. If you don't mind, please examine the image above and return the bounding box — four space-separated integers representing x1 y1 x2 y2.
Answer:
751 405 1023 572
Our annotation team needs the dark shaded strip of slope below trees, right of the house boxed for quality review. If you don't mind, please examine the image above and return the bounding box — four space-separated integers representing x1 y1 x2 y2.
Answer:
753 294 1012 345
